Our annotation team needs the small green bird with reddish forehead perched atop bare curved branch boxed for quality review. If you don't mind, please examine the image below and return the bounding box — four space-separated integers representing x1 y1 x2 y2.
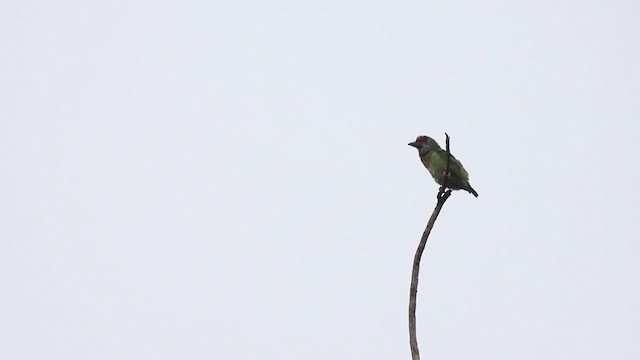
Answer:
407 135 478 197
